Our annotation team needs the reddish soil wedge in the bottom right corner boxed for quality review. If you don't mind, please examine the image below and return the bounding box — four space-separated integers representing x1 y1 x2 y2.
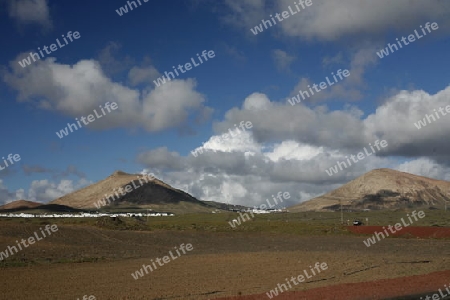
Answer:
216 271 450 300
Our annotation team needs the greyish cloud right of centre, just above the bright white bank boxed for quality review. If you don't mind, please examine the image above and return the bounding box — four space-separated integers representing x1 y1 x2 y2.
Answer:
215 93 364 148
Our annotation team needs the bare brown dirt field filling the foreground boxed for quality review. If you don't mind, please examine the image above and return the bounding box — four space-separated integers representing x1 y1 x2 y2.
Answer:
0 222 450 300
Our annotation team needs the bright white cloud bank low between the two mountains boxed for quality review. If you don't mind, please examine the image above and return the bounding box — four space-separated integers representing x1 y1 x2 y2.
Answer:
134 111 389 207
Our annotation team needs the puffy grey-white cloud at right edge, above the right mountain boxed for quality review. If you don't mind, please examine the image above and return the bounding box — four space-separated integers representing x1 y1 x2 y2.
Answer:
363 86 450 158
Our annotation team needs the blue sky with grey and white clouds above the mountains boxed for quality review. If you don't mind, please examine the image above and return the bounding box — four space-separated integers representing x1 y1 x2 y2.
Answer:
0 0 450 206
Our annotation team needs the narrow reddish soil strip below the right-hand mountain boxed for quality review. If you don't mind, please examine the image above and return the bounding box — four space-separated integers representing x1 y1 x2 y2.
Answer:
347 226 450 238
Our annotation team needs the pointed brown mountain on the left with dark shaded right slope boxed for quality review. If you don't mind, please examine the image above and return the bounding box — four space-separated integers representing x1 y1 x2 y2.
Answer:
50 171 211 214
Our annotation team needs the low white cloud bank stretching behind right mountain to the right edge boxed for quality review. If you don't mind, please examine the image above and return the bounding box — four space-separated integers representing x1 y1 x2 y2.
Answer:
137 127 450 206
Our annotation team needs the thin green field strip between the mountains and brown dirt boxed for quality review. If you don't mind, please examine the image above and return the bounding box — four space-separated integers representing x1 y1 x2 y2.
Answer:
4 210 450 235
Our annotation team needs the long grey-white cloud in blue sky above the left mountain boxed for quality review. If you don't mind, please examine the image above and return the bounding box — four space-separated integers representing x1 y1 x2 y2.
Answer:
3 55 212 132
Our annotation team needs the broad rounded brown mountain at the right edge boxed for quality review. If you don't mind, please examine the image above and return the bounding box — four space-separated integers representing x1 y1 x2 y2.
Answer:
289 169 450 212
